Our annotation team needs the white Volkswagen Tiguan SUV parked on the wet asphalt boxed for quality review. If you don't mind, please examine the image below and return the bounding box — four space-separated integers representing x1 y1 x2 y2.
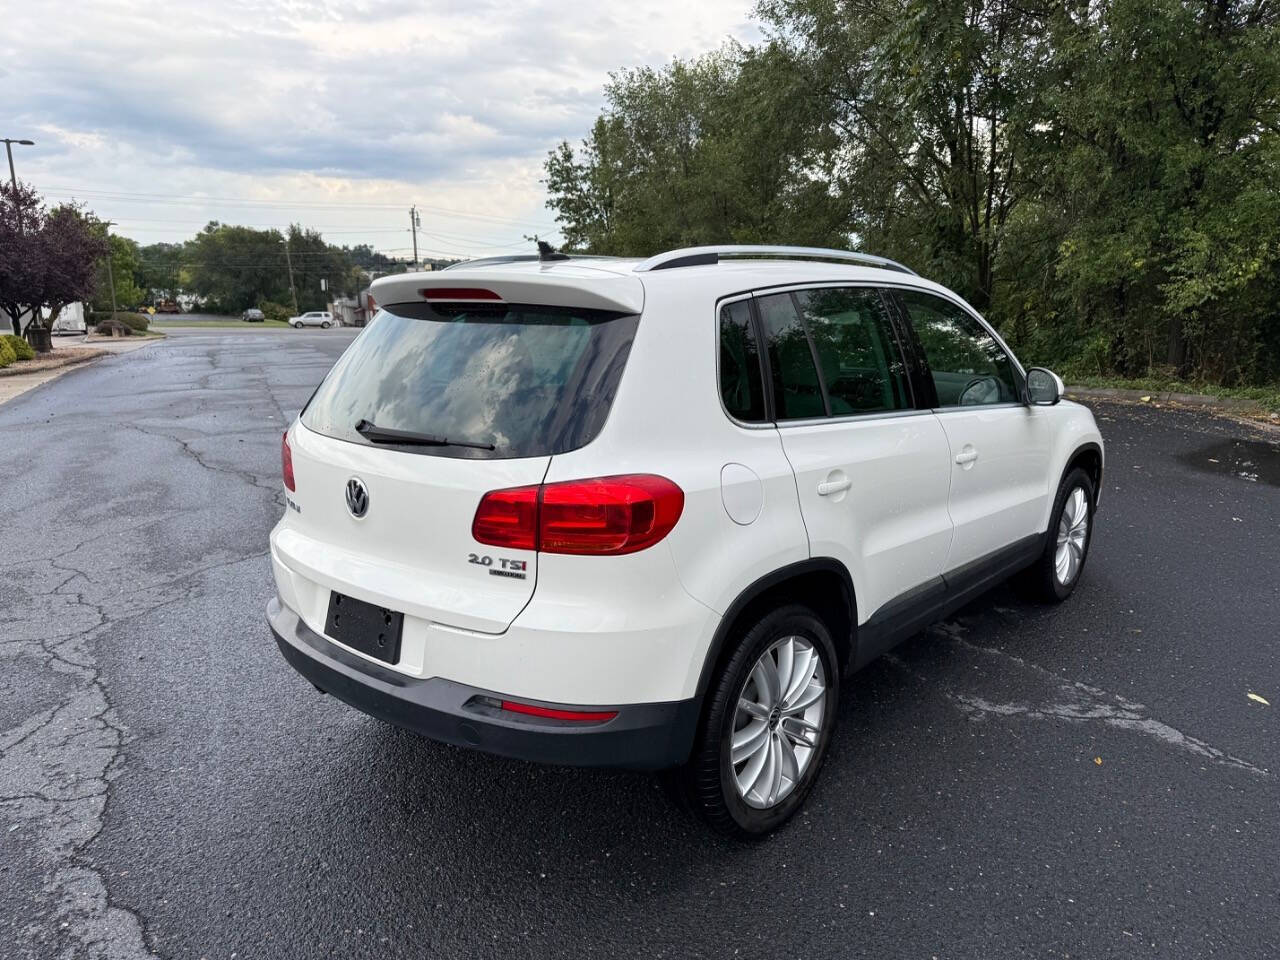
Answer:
268 247 1103 836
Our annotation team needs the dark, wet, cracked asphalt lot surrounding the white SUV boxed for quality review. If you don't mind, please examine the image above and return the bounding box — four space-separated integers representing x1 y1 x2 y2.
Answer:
0 330 1280 960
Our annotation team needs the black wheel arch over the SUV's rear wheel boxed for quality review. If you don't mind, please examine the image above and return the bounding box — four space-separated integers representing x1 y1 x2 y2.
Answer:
696 557 858 700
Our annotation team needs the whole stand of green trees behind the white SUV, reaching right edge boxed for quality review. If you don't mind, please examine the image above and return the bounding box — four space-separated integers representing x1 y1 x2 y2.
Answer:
555 0 1280 385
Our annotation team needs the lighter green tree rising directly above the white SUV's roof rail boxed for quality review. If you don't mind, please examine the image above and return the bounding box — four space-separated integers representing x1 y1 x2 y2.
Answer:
545 46 849 255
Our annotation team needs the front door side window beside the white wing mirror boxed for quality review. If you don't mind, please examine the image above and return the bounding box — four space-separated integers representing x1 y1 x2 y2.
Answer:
899 291 1020 407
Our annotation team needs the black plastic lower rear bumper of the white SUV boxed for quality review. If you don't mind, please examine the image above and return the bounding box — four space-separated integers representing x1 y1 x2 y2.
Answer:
266 598 699 771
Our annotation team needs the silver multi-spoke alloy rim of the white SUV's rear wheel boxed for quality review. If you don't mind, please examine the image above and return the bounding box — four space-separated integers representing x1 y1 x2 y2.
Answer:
730 636 827 810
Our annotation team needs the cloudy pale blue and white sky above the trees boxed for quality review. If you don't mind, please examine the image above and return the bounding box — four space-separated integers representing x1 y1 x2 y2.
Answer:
0 0 759 259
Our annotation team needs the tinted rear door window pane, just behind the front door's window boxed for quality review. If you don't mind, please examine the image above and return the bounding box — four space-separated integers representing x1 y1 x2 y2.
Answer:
794 287 911 417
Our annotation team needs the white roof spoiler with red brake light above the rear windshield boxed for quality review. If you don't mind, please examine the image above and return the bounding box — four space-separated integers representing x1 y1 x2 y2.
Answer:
370 261 644 314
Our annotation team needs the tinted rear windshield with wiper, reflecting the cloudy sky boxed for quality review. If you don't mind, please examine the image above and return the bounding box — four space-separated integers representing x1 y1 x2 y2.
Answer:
302 303 639 460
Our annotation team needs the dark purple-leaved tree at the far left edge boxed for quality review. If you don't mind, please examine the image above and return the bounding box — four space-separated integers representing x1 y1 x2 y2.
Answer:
0 182 106 334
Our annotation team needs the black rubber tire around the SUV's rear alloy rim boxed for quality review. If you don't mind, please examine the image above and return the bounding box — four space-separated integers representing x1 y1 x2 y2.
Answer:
672 604 840 838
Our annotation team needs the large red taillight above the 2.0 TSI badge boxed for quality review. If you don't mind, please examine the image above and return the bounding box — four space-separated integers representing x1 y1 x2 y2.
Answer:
471 474 685 556
